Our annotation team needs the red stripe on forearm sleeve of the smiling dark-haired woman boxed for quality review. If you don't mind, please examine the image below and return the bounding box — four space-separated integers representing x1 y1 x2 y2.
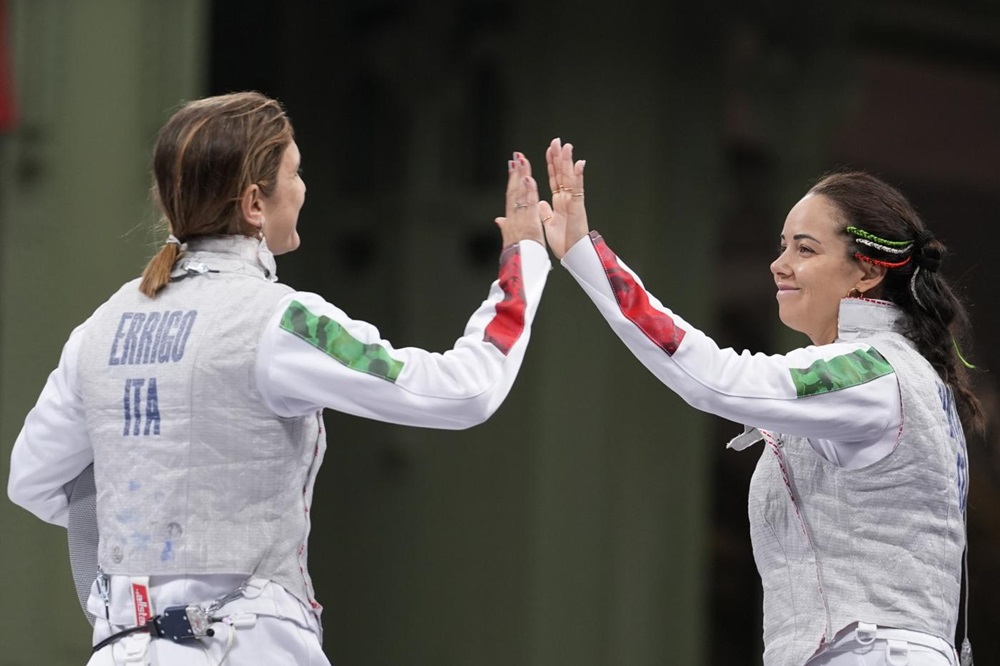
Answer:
590 231 684 356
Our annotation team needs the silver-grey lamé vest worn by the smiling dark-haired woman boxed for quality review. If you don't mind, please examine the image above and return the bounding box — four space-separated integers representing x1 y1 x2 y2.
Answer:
749 332 968 666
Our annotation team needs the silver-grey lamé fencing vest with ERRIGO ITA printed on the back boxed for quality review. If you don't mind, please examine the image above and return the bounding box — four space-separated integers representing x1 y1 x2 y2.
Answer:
79 238 326 609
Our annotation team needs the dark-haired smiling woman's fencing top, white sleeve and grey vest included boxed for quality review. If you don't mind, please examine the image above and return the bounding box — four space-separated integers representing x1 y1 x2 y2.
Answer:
562 232 968 666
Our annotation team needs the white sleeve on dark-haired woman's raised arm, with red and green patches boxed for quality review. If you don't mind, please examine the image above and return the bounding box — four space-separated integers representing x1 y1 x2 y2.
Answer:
562 232 900 444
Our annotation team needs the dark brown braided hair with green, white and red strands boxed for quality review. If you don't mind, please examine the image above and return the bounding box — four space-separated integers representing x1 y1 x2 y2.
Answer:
809 171 984 432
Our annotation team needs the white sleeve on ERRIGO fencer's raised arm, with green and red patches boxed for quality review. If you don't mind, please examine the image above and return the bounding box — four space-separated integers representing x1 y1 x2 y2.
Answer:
257 241 551 429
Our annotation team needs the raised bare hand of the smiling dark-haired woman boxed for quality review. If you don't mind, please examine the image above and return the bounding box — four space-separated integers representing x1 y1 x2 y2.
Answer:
538 139 590 259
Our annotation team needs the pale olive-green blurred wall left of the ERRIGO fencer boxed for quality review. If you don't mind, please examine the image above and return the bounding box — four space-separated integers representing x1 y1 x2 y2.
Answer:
0 0 207 666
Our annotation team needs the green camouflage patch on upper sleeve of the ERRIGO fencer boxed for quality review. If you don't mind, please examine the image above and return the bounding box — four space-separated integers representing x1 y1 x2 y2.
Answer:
281 301 403 383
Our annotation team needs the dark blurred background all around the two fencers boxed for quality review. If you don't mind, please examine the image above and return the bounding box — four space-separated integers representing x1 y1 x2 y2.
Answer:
0 0 1000 666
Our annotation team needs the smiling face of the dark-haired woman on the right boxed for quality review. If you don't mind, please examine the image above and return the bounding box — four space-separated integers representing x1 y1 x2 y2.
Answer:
771 194 864 345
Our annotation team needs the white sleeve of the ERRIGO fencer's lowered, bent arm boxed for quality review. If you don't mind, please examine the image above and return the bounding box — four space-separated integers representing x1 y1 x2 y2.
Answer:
7 320 94 527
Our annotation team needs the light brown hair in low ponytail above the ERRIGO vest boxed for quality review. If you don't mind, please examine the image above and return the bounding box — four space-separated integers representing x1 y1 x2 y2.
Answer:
139 92 295 298
